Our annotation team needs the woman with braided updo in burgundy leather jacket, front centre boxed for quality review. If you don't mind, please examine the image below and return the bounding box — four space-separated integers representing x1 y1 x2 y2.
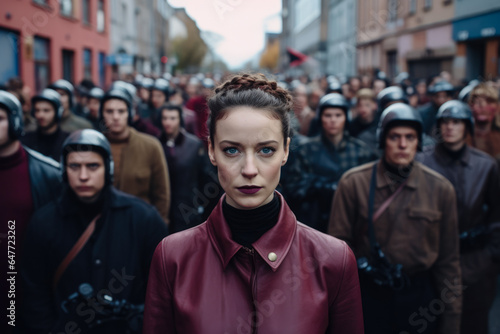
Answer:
143 74 363 334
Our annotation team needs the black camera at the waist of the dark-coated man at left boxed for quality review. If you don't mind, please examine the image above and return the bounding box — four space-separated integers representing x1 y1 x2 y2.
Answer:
61 283 144 334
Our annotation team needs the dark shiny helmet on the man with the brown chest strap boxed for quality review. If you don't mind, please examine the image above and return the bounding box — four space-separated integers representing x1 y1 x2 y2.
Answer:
61 129 114 185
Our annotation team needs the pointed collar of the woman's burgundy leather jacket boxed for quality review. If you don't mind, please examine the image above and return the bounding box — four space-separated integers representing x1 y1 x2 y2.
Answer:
207 191 297 271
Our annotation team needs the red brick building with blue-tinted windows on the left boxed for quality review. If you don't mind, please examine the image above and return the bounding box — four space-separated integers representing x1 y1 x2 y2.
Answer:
0 0 111 93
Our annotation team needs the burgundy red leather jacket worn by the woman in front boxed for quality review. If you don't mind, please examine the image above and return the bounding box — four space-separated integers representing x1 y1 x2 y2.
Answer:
143 194 363 334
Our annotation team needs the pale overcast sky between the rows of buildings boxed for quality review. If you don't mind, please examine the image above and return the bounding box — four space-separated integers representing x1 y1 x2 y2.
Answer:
168 0 281 68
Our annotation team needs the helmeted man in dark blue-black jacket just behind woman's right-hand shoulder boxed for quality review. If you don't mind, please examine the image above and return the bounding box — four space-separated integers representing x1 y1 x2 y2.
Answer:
284 93 377 232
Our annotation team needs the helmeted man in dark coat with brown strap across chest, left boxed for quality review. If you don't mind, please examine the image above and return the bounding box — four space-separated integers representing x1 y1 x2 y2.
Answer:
20 130 167 333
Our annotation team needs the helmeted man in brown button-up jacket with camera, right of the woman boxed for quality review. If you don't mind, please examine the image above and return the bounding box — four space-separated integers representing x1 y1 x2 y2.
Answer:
329 103 463 334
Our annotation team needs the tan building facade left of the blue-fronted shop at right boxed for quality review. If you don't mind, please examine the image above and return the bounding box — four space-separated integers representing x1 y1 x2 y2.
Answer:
357 0 459 80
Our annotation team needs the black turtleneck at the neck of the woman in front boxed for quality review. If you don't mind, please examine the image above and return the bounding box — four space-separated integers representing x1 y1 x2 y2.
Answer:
222 194 281 248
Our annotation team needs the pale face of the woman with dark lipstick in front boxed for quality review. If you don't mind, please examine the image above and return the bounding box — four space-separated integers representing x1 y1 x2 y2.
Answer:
208 106 290 209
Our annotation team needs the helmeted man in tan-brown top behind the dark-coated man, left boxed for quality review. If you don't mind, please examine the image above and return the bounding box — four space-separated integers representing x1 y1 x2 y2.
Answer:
100 87 170 223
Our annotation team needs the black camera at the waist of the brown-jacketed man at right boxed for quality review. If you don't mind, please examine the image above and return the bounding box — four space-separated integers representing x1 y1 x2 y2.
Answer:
357 247 410 291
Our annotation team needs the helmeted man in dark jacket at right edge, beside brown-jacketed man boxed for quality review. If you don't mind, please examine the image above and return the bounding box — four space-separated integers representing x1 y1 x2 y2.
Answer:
419 100 500 334
